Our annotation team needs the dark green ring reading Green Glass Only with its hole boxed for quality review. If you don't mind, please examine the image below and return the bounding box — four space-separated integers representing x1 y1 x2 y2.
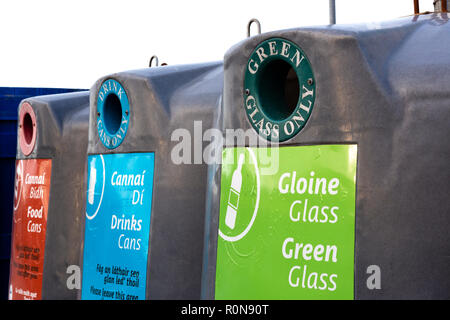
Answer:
244 38 316 142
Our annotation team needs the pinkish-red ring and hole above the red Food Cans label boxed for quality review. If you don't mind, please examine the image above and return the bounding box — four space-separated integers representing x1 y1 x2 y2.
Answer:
19 102 37 156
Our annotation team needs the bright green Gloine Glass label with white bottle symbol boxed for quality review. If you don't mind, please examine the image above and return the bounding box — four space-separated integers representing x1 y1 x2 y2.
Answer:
215 145 357 299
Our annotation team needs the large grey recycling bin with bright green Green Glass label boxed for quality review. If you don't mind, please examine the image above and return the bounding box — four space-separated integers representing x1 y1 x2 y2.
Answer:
202 14 450 299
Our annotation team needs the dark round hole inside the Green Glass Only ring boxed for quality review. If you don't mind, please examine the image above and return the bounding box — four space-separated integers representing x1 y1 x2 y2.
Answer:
256 59 300 121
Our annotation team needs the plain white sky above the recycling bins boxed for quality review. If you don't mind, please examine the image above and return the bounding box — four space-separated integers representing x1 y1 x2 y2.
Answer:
0 0 433 88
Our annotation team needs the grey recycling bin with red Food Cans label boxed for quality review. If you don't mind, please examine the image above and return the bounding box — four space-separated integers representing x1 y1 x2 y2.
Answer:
8 91 89 300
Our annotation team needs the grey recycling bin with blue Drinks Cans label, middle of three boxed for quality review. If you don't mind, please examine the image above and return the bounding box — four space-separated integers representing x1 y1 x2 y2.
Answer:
81 62 223 300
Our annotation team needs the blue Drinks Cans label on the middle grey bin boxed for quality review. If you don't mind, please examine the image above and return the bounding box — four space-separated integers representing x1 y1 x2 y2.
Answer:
81 153 155 300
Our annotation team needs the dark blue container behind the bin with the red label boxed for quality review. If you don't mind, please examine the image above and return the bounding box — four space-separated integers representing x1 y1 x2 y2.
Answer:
0 87 80 300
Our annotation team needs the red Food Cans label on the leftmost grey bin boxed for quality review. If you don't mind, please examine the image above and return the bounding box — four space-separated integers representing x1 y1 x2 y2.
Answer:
9 159 52 300
